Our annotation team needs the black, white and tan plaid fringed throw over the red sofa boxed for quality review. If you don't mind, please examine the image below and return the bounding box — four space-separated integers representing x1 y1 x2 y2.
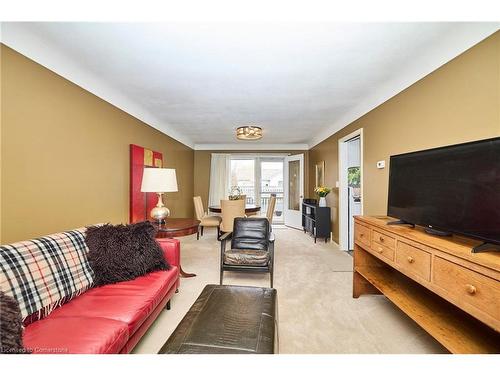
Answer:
0 228 94 324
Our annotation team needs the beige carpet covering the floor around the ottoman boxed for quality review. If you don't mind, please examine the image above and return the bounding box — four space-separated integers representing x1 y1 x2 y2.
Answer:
134 228 443 354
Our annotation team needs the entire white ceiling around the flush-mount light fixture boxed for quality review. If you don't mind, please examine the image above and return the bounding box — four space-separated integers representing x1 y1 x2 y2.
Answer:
2 22 499 149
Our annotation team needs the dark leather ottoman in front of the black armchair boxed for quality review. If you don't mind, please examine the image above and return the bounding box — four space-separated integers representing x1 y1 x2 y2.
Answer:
159 285 278 354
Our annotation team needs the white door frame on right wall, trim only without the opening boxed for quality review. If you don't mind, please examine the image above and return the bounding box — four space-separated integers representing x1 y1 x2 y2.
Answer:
339 128 365 251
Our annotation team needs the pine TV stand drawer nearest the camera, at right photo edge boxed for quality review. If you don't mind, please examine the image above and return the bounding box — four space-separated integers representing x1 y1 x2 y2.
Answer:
432 256 500 320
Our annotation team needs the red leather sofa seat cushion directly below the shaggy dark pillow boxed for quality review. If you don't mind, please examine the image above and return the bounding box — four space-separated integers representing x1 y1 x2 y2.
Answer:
45 267 179 336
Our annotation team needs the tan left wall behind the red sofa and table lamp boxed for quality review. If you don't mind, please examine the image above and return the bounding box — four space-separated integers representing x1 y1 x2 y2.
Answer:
1 45 194 243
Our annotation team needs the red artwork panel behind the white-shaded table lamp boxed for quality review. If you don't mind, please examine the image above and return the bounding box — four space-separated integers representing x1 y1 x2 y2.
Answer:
129 144 163 223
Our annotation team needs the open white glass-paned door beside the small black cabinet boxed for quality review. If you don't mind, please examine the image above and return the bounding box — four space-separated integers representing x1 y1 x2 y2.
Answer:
284 154 304 229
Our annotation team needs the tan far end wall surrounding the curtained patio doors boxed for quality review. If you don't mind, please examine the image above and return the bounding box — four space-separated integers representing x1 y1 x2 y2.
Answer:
194 150 309 210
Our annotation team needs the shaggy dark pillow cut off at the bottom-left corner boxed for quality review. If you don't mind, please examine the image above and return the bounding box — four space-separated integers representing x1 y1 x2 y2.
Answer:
0 290 28 354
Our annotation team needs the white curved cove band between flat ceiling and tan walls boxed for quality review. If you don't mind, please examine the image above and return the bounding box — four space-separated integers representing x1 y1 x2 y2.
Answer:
0 22 500 151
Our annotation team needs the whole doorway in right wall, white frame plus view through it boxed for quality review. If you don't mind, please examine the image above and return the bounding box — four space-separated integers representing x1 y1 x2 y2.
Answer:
339 129 364 251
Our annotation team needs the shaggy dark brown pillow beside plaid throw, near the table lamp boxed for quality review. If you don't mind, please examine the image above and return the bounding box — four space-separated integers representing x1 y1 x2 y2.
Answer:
85 221 170 286
